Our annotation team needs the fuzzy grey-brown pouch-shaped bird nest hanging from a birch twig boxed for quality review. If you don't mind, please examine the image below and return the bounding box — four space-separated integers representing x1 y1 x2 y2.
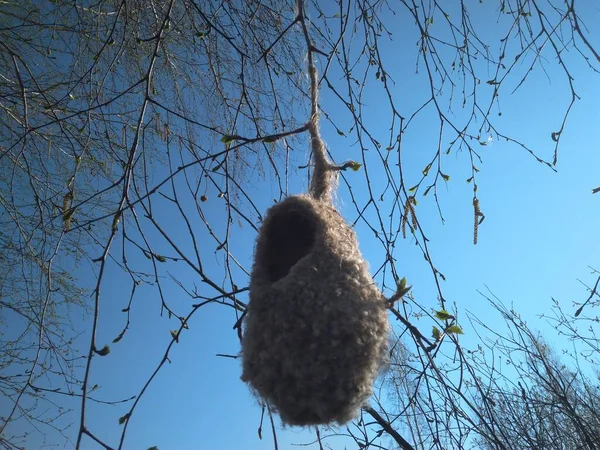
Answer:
242 196 389 425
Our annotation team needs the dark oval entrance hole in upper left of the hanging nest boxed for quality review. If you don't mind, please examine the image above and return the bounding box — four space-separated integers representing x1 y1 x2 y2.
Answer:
264 210 317 282
